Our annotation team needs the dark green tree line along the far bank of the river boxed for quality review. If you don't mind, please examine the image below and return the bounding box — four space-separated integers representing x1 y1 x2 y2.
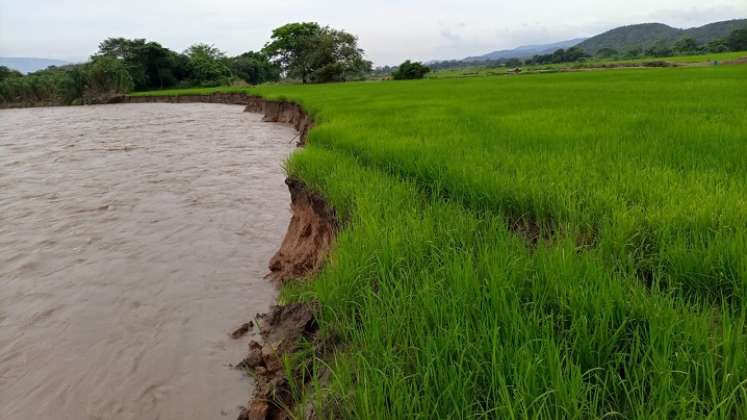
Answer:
0 22 371 105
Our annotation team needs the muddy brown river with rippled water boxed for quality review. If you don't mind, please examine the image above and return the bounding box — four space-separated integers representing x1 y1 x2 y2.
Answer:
0 104 296 420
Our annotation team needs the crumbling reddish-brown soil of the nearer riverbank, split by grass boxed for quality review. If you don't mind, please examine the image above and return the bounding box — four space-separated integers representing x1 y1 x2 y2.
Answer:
238 178 339 420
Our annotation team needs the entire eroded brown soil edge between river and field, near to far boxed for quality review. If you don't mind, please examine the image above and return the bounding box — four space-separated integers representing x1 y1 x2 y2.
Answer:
122 93 340 420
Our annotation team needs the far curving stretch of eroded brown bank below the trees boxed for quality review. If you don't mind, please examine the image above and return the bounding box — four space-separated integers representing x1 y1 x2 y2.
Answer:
121 93 314 146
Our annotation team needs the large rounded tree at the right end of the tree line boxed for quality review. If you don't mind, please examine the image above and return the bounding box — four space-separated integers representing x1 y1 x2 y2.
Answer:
263 22 371 83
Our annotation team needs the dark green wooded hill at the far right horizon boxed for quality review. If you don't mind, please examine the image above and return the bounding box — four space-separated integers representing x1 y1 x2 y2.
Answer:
578 19 747 54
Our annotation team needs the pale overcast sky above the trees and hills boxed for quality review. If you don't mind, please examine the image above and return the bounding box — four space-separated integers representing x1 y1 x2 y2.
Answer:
0 0 747 65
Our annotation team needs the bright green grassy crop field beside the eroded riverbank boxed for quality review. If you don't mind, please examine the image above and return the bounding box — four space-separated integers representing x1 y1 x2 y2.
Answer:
136 64 747 419
